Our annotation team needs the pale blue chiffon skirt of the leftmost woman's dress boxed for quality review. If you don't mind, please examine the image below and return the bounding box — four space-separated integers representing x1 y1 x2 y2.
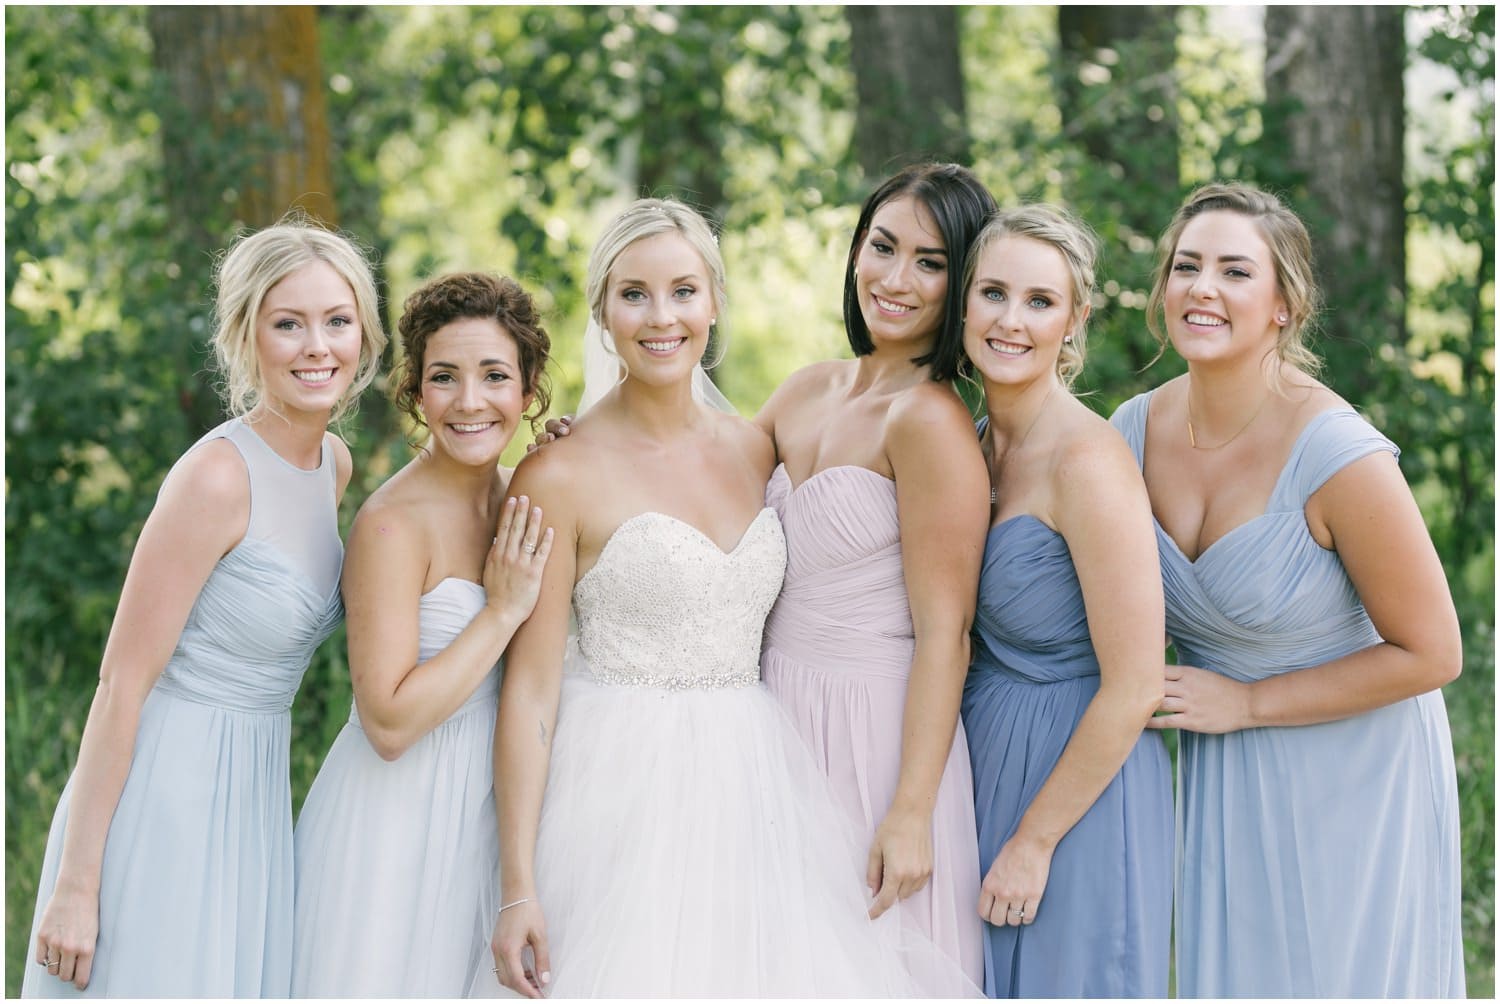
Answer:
23 684 293 998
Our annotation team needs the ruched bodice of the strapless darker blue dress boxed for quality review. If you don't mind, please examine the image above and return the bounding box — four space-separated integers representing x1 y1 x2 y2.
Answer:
971 513 1100 683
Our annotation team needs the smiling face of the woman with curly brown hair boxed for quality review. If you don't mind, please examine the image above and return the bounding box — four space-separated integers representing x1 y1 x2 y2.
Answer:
422 317 531 467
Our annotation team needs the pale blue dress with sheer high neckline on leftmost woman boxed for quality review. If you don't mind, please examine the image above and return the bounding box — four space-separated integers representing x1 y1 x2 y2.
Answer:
21 419 344 998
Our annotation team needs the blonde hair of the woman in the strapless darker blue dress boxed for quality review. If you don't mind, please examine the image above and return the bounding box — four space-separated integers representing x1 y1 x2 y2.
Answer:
963 203 1100 390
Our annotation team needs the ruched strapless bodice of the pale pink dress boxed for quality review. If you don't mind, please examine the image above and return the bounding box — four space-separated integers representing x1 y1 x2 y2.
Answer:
767 465 914 680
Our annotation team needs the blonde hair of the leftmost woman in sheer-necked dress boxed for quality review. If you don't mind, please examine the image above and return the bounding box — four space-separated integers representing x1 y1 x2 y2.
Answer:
213 215 386 419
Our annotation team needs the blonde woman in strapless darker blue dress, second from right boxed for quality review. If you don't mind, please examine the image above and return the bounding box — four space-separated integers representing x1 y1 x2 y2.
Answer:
963 206 1172 998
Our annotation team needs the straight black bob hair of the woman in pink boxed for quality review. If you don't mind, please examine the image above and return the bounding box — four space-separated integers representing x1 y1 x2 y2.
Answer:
845 164 999 383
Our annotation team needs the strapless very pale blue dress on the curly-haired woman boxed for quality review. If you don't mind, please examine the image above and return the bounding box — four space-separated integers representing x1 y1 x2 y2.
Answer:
291 578 500 998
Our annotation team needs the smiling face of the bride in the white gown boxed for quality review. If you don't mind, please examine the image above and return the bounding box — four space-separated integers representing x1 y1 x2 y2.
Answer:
603 231 716 384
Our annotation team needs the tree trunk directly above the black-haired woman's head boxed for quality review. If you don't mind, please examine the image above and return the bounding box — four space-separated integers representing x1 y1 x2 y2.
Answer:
845 6 969 177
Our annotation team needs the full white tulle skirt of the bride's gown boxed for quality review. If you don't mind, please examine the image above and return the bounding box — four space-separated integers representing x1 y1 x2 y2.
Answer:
474 674 980 998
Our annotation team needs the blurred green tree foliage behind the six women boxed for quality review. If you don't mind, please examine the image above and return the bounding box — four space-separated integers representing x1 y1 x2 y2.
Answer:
5 6 1494 996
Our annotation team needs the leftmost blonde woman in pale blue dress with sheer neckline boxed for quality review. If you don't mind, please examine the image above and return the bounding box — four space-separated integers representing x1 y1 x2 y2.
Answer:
21 222 386 998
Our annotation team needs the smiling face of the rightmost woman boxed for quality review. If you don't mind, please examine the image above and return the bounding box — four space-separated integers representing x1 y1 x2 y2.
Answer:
1163 212 1287 363
